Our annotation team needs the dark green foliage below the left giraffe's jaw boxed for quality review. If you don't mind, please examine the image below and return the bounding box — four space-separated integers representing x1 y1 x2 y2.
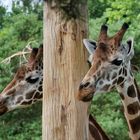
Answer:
0 103 42 140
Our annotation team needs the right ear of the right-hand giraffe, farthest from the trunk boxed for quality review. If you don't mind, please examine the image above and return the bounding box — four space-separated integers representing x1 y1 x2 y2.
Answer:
126 38 134 58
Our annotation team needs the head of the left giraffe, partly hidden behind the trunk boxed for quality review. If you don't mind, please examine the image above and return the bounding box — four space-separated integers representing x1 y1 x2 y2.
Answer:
0 45 43 115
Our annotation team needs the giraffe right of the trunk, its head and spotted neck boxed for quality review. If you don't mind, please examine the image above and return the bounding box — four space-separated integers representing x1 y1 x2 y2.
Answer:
77 23 140 140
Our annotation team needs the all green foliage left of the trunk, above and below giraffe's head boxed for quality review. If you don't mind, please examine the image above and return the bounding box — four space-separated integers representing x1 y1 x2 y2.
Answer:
0 0 43 140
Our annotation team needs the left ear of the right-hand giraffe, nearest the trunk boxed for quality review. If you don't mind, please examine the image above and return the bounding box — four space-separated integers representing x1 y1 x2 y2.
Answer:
83 39 97 55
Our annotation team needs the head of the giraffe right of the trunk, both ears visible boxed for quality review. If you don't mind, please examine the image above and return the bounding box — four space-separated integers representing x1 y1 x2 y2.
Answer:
78 23 134 101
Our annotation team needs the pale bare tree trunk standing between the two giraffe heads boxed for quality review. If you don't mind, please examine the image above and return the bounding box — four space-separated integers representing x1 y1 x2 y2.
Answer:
43 0 88 140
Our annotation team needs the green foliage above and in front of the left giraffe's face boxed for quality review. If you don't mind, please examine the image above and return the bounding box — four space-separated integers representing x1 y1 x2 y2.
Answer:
0 1 43 90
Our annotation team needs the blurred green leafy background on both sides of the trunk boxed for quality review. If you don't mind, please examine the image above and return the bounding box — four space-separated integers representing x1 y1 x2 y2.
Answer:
0 0 140 140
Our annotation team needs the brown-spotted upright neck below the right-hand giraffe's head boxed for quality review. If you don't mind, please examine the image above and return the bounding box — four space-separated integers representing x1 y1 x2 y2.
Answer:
118 70 140 140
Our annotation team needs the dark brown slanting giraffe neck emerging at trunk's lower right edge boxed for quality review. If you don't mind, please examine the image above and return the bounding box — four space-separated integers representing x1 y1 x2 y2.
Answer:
89 115 110 140
